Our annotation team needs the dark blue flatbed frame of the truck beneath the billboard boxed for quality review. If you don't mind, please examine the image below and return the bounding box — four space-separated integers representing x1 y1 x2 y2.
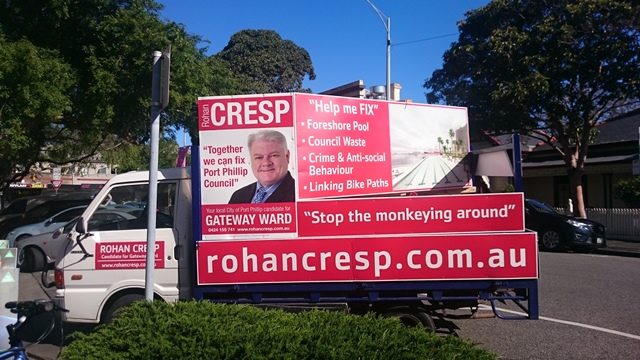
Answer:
191 146 539 327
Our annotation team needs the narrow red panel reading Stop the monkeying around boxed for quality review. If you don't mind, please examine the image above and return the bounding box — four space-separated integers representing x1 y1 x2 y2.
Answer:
297 193 524 236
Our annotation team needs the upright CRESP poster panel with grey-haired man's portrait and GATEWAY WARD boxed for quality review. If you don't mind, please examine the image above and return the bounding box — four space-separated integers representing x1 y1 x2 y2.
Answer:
198 94 298 239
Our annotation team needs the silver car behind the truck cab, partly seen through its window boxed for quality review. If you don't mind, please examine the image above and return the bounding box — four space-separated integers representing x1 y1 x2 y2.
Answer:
15 209 136 272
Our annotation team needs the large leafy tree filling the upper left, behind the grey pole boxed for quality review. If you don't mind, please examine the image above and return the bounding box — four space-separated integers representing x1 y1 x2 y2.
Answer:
0 0 236 190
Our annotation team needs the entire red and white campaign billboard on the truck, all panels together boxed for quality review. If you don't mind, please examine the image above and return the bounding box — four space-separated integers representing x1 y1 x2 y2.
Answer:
197 93 537 285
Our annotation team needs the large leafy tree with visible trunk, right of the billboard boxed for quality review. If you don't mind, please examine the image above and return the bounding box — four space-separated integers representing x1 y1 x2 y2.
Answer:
424 0 640 217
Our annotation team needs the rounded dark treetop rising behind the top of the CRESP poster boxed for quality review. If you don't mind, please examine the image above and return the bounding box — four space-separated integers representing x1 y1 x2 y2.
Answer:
216 30 316 94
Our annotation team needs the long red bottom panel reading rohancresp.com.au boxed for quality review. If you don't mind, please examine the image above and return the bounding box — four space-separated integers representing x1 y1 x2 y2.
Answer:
196 232 538 285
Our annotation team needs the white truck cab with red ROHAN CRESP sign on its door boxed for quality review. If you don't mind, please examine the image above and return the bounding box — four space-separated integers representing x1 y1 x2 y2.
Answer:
64 181 178 321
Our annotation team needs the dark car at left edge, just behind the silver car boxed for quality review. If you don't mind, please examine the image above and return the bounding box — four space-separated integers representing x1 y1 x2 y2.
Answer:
0 194 91 239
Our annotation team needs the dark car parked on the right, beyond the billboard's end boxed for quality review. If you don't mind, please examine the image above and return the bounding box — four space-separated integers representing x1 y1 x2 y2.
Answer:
524 199 607 251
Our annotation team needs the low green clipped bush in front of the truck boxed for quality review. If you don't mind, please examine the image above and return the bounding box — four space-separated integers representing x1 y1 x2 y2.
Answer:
61 301 496 360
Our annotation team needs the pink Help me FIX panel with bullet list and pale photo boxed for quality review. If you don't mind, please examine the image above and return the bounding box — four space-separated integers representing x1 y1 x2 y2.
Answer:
295 94 471 199
